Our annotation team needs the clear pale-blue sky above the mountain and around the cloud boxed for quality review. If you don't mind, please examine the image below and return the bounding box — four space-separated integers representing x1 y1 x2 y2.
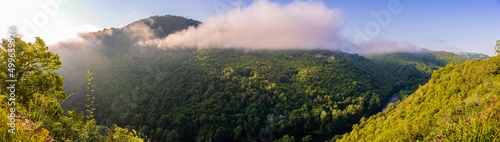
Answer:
0 0 500 56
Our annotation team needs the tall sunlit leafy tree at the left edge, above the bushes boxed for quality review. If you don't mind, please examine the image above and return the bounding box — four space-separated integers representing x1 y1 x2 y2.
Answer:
0 36 66 118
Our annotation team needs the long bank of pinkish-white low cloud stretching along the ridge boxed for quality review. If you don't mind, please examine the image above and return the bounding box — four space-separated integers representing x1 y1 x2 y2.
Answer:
52 0 421 54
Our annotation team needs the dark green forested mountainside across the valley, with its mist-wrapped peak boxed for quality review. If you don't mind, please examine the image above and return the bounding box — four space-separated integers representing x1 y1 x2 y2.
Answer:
54 16 463 141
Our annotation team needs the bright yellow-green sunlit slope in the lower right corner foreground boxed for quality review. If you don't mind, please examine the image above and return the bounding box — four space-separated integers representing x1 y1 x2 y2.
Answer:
340 57 500 141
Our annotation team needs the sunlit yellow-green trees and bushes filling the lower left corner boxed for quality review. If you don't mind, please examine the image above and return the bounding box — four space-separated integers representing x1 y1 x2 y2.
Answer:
0 37 142 141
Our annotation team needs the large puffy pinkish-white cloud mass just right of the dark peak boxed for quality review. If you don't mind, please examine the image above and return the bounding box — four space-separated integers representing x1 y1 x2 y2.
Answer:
138 0 342 50
